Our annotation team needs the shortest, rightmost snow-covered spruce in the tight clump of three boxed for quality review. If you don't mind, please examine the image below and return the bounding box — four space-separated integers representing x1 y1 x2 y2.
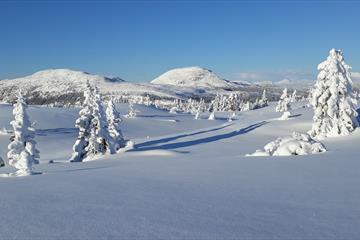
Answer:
106 100 126 151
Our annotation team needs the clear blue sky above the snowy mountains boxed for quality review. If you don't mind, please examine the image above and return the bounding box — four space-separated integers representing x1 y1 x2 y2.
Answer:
0 1 360 81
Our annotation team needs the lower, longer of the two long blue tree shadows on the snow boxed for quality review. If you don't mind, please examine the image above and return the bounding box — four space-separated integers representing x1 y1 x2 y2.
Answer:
132 121 267 151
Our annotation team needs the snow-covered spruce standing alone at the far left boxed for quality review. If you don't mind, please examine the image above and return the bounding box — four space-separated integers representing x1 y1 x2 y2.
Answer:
7 93 40 176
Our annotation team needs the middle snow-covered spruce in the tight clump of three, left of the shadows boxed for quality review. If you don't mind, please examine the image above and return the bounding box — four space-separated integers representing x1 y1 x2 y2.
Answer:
83 87 115 161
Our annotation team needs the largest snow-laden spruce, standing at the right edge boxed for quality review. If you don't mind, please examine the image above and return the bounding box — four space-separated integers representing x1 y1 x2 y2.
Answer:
310 49 359 138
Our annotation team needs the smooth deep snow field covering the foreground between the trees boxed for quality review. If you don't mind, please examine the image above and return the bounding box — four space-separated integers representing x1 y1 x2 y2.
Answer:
0 103 360 239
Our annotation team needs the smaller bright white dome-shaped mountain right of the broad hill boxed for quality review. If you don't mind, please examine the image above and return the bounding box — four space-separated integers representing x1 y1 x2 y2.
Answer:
151 67 233 88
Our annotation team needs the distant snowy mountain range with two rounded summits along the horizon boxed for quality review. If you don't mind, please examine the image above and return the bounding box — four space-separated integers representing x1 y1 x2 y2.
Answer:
0 67 310 104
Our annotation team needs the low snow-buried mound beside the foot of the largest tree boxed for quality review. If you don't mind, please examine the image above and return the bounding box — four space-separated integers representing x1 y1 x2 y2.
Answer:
246 132 326 156
